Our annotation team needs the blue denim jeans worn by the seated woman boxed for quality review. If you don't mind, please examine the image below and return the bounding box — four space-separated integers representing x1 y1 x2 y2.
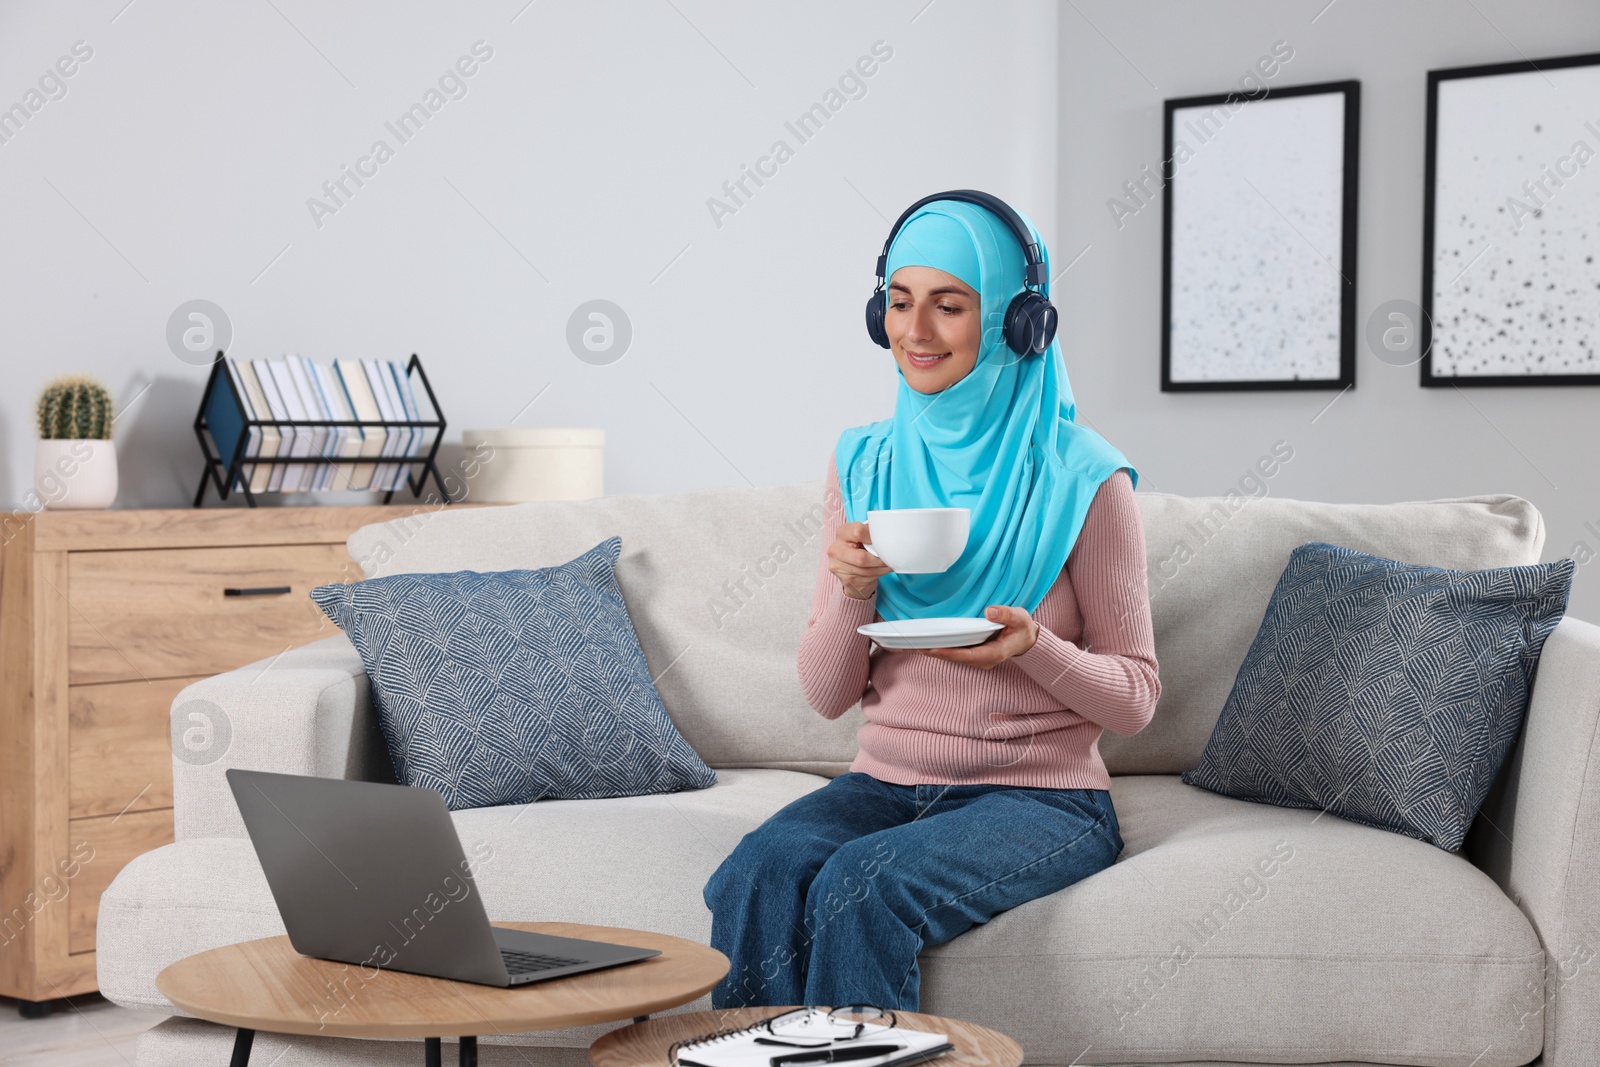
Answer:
702 771 1123 1011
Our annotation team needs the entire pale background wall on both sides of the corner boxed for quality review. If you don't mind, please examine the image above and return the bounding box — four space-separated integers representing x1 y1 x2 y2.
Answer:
15 0 1600 619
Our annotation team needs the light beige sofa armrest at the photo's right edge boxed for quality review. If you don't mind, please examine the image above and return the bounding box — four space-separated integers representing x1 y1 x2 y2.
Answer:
1469 616 1600 1067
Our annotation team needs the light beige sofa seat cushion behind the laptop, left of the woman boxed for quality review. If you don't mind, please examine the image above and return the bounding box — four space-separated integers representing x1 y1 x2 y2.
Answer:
94 769 827 1017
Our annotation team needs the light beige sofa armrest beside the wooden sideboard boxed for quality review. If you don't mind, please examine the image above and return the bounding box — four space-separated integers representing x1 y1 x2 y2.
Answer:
171 633 394 841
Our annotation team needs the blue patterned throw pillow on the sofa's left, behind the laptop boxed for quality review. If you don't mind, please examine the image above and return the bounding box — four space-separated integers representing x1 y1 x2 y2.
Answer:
310 537 717 811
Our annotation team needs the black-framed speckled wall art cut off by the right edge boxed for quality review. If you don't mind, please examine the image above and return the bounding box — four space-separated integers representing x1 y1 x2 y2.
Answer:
1419 54 1600 387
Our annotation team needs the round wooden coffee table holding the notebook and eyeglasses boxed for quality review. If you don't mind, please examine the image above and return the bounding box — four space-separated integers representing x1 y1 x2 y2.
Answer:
589 1006 1022 1067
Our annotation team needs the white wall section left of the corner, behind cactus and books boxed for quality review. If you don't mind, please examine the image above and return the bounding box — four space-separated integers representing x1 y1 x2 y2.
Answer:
0 0 1058 507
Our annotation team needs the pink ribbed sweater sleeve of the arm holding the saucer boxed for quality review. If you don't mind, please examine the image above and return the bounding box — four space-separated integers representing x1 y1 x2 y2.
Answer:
1016 467 1162 736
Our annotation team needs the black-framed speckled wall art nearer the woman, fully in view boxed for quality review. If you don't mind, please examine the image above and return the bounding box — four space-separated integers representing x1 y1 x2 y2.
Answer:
1162 82 1362 392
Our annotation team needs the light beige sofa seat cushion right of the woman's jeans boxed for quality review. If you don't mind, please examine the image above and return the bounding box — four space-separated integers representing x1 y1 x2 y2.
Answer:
922 774 1544 1067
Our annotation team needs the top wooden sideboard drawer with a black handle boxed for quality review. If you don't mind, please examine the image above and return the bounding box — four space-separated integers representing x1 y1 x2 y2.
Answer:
67 544 362 685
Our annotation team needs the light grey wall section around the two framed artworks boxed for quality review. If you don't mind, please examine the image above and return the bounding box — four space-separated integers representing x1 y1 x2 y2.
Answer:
1054 0 1600 621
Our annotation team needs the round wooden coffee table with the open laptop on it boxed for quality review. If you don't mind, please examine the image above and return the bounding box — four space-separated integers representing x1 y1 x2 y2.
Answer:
155 923 728 1067
